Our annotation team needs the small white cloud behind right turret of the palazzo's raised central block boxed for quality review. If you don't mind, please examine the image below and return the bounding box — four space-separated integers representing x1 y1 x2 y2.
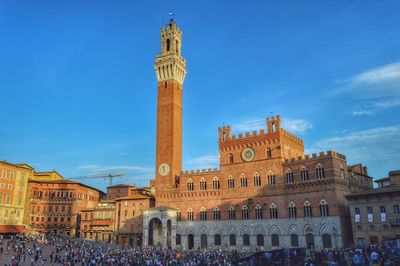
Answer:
232 117 312 134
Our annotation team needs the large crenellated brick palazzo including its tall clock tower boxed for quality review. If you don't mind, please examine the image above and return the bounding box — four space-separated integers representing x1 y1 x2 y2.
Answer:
143 20 372 250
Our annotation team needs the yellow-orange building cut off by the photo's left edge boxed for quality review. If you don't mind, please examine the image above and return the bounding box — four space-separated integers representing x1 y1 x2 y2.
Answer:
0 161 34 234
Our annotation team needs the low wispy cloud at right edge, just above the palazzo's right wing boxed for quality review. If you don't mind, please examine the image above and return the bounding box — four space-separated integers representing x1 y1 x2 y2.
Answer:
307 125 400 164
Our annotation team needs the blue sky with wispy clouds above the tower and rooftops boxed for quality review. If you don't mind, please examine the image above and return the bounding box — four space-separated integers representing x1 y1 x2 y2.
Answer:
0 0 400 191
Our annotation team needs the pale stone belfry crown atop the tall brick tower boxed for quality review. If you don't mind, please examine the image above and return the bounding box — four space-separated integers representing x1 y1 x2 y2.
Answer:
154 19 186 85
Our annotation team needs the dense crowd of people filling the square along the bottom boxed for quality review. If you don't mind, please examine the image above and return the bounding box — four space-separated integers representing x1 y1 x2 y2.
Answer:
0 235 400 266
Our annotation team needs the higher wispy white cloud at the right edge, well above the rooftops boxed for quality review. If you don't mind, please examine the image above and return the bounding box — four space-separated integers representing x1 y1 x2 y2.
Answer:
332 62 400 116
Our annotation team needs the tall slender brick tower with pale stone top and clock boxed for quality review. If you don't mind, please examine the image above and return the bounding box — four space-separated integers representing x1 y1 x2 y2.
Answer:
154 19 186 192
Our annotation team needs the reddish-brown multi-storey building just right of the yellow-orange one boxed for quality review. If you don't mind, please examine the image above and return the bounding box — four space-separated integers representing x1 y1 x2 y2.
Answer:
26 171 105 237
